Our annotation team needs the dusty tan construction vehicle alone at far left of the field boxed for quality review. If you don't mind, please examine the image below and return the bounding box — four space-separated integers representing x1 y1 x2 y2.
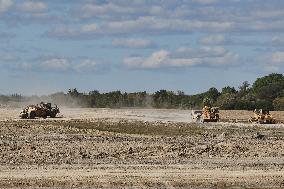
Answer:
20 102 60 119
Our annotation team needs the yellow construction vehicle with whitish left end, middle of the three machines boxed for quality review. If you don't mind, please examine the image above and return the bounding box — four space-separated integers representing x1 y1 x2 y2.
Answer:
191 106 220 123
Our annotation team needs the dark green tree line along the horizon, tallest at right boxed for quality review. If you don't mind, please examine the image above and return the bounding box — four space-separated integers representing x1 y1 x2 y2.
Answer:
0 73 284 110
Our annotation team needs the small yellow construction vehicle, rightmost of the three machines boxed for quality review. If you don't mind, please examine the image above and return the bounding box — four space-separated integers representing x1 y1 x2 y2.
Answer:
249 109 276 124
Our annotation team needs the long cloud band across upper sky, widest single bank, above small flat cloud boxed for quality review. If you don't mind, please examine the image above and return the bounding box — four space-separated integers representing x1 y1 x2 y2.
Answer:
47 17 233 39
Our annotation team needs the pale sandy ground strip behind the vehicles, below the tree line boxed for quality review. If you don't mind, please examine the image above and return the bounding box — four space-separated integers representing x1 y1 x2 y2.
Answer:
0 108 284 123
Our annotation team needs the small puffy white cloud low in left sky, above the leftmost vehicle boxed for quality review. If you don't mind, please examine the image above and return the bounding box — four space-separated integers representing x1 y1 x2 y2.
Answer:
40 58 71 72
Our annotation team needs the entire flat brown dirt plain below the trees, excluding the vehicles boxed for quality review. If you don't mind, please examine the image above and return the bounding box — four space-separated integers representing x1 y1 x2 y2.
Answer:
0 108 284 189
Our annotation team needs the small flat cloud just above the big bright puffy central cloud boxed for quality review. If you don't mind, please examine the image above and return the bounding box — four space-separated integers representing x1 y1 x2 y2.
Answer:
112 39 155 48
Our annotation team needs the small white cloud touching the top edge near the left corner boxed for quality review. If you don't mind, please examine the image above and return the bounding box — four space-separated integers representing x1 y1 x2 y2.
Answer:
17 1 47 12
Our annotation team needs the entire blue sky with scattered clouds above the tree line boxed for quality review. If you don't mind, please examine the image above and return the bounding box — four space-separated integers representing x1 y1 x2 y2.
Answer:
0 0 284 95
